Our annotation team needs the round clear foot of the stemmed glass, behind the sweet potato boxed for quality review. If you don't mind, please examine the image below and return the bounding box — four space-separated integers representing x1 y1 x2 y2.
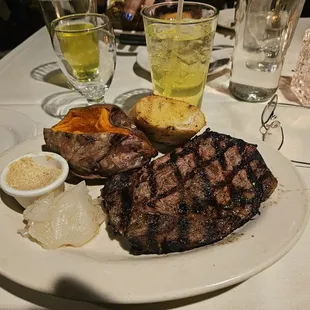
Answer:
42 91 89 118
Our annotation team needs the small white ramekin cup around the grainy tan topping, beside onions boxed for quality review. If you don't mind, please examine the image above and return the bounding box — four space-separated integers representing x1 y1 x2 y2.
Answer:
0 152 69 208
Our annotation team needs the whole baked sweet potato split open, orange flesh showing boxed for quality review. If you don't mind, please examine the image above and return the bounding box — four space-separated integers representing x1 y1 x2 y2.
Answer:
44 104 157 179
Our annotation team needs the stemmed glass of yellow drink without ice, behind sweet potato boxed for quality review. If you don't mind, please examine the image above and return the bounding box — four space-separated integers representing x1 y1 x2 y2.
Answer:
47 13 116 117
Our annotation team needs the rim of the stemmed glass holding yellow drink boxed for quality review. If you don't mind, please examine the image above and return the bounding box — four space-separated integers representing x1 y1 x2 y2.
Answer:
51 13 109 33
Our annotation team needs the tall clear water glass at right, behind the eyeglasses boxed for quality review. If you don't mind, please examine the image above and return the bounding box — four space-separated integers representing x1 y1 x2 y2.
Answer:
229 0 305 102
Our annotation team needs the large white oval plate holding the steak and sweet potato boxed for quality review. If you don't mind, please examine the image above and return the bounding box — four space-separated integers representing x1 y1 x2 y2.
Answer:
0 126 309 303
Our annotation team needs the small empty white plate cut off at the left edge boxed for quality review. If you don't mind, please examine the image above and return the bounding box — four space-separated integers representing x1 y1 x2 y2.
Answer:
0 109 37 153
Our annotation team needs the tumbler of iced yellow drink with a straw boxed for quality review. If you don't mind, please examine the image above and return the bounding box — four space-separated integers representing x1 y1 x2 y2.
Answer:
141 2 218 107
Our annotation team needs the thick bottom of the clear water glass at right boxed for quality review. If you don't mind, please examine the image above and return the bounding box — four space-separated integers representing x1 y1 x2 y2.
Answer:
229 82 278 102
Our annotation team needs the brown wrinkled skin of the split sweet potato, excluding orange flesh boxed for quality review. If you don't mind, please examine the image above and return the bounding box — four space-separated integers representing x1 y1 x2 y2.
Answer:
43 104 157 179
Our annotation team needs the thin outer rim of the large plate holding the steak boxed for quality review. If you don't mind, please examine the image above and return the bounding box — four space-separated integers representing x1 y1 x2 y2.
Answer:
0 130 310 303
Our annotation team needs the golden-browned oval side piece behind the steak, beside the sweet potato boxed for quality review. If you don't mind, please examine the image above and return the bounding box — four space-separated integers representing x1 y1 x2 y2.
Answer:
129 95 206 145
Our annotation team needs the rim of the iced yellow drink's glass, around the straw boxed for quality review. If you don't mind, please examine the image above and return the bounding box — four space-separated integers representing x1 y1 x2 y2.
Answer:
141 1 219 25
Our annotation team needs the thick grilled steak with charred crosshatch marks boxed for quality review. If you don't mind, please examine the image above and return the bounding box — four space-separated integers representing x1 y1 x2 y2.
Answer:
102 130 277 254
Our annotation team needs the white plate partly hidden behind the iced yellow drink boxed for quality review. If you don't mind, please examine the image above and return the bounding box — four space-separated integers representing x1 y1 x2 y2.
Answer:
137 47 233 75
